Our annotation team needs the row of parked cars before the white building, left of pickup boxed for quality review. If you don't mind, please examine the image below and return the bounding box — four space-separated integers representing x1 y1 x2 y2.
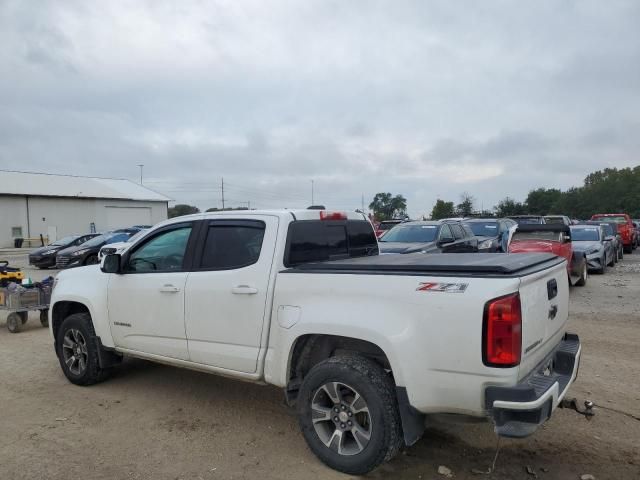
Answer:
29 225 148 269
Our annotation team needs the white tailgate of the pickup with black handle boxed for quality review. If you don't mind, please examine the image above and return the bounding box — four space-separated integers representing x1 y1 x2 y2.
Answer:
519 262 569 378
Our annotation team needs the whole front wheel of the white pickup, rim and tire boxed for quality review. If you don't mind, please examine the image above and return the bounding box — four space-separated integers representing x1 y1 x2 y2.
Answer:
56 313 106 385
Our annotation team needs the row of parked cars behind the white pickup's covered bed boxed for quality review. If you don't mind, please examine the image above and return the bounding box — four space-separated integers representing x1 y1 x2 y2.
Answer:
377 208 640 286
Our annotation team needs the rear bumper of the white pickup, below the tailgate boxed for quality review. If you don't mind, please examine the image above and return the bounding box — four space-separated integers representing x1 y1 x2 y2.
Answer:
485 333 582 438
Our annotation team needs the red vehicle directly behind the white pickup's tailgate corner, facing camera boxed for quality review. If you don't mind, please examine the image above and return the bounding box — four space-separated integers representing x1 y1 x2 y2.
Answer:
509 224 587 287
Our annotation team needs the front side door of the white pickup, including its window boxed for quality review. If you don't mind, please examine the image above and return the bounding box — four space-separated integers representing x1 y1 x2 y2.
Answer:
107 222 194 360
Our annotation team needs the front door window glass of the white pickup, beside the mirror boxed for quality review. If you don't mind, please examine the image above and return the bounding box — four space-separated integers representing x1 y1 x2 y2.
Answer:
126 226 191 273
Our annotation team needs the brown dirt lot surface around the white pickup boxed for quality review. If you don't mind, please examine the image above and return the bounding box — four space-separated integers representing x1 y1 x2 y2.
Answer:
0 253 640 480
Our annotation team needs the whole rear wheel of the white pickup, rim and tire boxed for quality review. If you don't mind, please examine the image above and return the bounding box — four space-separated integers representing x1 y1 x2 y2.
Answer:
298 355 402 475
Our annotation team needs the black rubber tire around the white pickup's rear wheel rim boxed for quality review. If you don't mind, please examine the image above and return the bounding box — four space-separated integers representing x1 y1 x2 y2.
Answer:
298 355 403 475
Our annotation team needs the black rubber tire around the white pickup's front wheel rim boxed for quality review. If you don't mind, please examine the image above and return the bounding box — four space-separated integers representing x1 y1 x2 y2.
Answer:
56 313 108 386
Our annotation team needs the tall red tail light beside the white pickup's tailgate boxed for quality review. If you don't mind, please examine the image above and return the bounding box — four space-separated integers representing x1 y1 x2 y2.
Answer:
482 293 522 368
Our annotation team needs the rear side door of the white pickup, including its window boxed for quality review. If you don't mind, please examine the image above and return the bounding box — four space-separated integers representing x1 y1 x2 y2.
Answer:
185 216 278 373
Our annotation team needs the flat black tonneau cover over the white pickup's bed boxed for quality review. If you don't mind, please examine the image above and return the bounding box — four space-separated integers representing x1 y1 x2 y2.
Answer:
284 253 564 276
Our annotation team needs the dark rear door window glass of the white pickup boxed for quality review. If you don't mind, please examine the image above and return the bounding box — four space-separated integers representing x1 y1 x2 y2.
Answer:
200 221 265 270
